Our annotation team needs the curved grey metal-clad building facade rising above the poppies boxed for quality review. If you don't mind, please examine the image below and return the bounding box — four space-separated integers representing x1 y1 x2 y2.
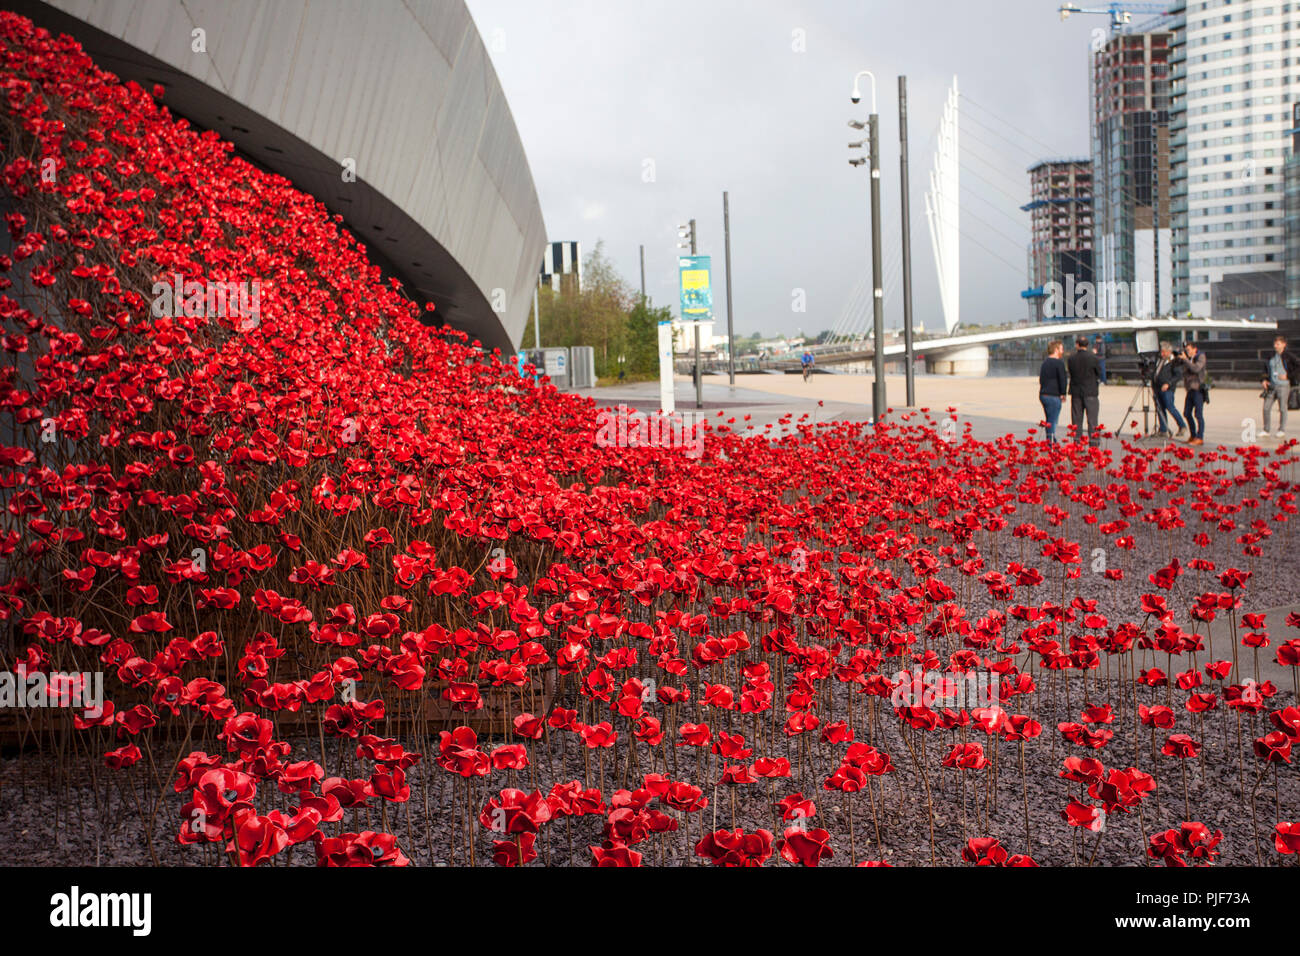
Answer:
17 0 546 350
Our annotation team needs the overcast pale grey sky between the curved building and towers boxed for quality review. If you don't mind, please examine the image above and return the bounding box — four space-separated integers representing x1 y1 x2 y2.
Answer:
469 0 1106 336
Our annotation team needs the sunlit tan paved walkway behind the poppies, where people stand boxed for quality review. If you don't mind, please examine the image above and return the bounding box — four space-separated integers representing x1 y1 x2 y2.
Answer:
580 373 1300 447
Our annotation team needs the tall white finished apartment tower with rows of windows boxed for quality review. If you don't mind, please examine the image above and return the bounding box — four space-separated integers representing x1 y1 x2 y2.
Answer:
1169 0 1300 319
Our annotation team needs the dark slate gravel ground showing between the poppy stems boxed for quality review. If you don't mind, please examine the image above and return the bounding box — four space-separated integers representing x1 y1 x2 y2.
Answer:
0 447 1300 866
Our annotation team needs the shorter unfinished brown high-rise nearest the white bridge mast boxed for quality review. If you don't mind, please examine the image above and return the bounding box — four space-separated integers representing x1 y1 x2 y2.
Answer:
1021 159 1093 321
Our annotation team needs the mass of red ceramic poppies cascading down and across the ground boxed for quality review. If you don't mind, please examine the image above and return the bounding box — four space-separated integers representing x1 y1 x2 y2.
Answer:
0 13 1300 866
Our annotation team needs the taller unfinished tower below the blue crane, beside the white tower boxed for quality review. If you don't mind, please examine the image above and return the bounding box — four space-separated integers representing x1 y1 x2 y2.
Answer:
1092 31 1173 317
